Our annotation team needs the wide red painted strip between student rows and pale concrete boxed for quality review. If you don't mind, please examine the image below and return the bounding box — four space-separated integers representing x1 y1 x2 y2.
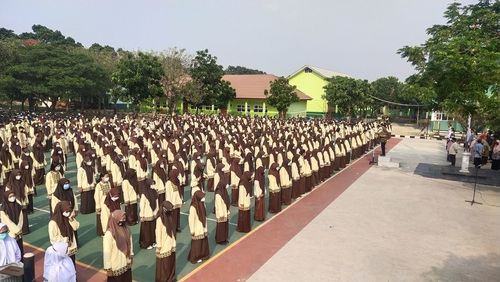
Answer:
186 138 401 281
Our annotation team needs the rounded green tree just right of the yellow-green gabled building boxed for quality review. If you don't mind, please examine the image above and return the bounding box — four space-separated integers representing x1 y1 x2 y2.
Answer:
324 76 372 118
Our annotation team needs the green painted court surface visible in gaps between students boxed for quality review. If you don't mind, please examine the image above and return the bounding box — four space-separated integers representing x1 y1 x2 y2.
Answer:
23 153 282 281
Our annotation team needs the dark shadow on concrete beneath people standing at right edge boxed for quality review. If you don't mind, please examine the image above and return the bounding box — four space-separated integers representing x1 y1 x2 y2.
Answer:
413 163 500 191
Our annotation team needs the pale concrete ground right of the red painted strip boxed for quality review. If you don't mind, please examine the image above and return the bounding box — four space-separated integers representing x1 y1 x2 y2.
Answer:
249 139 500 281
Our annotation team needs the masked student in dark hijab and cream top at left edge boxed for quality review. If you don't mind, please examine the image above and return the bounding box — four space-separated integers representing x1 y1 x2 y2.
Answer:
0 191 24 257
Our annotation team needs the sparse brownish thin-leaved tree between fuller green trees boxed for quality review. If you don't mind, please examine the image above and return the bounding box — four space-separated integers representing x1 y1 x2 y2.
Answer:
159 48 193 113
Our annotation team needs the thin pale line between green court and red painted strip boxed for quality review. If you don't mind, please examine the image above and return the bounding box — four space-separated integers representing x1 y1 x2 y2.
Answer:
182 145 380 282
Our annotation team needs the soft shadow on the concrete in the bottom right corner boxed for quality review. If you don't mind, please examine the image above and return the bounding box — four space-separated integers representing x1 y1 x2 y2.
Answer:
422 253 500 282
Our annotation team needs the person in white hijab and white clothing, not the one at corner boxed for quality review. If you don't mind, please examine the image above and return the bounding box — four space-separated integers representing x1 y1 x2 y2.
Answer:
43 242 76 282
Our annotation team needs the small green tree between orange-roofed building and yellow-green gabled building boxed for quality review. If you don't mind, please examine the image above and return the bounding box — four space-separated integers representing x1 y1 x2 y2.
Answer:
264 77 299 118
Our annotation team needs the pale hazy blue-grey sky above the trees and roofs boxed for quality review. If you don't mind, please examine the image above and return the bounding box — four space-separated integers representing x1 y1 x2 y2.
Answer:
0 0 477 81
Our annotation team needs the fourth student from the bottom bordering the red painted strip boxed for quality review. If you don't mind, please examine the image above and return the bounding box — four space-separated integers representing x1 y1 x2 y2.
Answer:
236 171 253 233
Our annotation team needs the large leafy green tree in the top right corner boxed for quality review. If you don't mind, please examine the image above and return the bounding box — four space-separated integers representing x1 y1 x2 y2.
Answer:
398 0 500 122
